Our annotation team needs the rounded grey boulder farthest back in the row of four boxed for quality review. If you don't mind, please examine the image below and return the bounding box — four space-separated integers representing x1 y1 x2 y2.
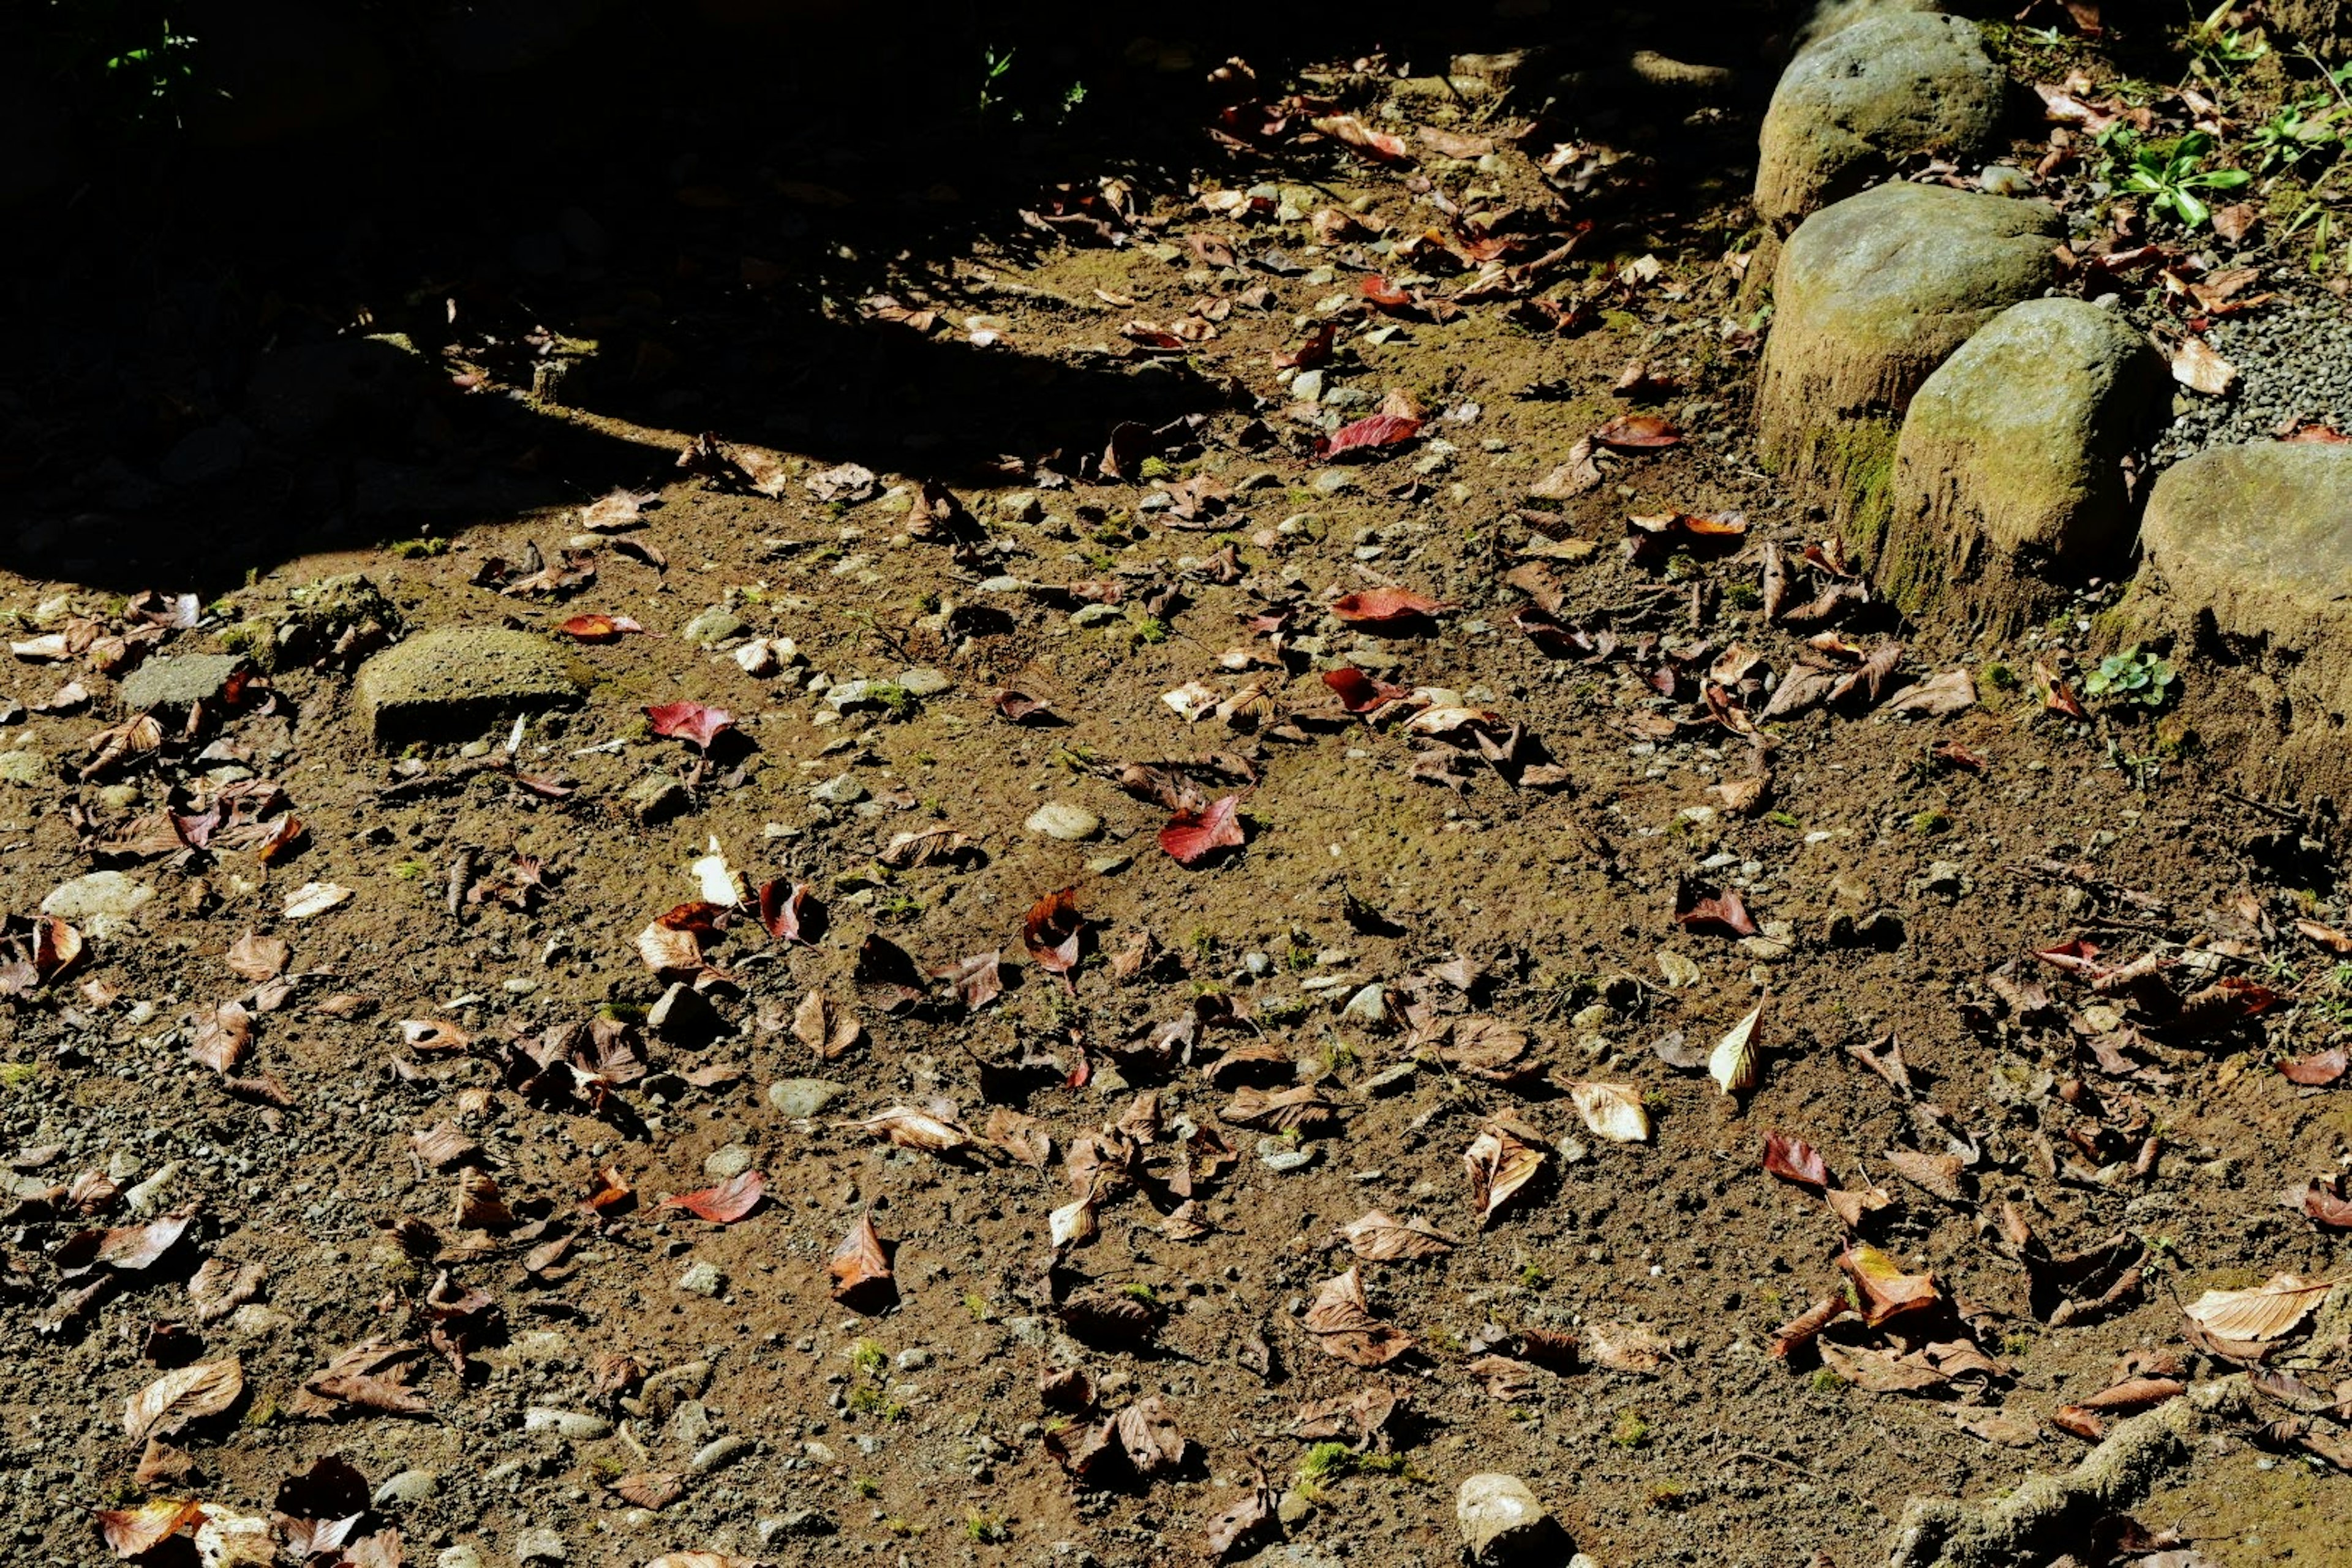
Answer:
1757 9 2008 228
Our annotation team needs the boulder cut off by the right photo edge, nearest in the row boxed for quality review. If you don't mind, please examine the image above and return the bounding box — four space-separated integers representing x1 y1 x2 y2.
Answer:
2122 442 2352 799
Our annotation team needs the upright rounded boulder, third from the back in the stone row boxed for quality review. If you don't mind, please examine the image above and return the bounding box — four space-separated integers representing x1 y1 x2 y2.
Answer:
1877 298 2168 637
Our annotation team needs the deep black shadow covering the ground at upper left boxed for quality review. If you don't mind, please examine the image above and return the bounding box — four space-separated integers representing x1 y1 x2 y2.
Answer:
0 0 1834 595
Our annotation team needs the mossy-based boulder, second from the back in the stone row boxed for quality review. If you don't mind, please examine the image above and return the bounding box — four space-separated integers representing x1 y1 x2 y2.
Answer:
1757 183 2063 557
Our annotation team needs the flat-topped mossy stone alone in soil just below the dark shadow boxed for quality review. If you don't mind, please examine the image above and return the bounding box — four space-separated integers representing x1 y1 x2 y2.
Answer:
355 628 581 743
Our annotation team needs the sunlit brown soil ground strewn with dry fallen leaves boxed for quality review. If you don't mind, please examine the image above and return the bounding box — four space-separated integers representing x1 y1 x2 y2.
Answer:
0 3 2352 1566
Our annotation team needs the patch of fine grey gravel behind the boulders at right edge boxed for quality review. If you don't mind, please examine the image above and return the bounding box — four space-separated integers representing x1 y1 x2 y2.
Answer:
2154 294 2352 466
